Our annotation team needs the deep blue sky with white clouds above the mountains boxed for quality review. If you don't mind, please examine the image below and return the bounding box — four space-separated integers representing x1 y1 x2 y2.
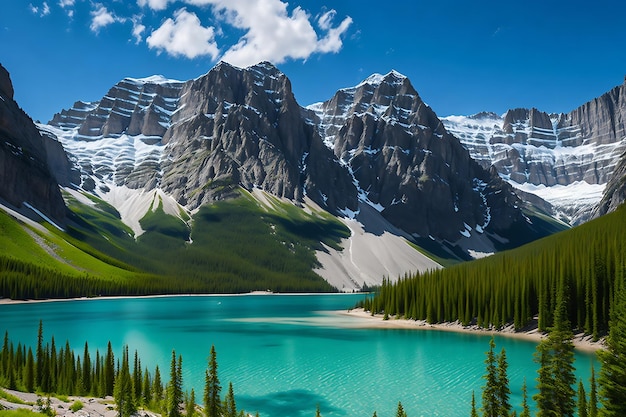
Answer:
0 0 626 122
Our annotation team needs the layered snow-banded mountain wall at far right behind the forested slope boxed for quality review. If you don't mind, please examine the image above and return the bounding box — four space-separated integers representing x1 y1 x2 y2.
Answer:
442 79 626 224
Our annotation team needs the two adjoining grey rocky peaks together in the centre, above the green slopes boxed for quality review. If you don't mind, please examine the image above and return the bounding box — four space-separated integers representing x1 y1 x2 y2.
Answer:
48 63 544 250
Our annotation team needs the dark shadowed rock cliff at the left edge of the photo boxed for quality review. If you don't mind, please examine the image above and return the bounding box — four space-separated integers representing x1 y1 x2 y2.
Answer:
0 65 69 222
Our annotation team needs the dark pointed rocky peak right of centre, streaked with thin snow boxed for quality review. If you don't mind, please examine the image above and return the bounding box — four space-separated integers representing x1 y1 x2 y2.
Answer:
309 71 521 242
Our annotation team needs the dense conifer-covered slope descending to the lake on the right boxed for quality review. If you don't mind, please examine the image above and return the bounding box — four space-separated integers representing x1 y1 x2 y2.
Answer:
363 206 626 337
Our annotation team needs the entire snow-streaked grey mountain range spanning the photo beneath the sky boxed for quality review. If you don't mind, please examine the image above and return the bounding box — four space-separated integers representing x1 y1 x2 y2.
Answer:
0 63 626 290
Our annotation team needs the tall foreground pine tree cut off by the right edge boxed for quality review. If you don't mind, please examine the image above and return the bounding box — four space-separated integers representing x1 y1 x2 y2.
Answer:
598 274 626 417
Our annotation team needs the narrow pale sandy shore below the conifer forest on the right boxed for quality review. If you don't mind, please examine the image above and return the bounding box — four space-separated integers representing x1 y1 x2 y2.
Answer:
338 308 605 352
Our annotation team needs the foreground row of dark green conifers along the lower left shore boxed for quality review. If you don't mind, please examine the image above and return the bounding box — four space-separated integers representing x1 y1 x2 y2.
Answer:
0 322 251 417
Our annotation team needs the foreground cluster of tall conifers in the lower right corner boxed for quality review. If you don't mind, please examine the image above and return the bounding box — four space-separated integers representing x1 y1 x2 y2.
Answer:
470 274 626 417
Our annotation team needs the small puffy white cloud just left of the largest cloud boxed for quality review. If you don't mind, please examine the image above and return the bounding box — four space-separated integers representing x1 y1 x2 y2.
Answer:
146 8 219 59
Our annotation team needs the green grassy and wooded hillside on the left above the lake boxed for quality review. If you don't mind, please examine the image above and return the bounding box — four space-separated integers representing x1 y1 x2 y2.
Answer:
0 190 349 298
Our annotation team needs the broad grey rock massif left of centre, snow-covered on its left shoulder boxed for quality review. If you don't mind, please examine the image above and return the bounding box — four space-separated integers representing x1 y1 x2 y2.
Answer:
48 63 357 213
